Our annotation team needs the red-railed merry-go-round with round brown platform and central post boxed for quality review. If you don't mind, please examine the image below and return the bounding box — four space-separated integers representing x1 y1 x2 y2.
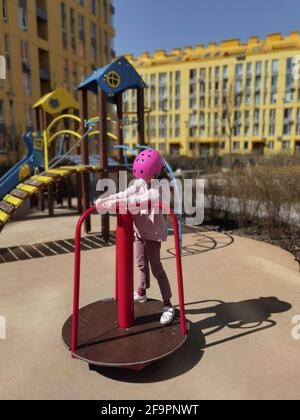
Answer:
63 205 189 371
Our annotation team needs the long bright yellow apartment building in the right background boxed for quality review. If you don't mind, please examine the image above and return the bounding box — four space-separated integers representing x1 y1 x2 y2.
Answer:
125 32 300 157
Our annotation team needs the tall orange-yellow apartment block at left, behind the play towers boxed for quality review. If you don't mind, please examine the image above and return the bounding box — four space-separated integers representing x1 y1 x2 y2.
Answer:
0 0 115 161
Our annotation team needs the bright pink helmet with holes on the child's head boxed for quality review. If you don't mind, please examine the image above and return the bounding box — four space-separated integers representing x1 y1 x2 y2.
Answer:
133 149 165 179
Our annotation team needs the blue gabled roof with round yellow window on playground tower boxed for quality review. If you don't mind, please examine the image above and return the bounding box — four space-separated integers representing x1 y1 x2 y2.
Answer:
78 57 146 101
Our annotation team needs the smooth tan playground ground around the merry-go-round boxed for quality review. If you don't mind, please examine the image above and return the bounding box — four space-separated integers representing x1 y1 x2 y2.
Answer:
0 212 300 399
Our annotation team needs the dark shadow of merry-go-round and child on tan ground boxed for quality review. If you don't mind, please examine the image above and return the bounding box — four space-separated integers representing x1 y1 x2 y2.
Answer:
90 297 292 383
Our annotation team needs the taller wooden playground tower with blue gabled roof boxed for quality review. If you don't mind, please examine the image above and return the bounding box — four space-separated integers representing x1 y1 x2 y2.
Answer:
78 57 146 236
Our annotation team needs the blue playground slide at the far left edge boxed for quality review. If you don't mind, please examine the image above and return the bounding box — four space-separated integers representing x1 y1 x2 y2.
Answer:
0 133 35 200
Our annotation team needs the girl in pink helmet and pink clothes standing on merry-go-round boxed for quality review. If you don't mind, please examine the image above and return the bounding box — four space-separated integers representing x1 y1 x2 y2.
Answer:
95 149 175 325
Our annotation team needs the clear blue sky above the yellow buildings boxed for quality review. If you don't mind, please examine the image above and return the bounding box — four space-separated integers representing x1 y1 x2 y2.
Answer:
114 0 300 55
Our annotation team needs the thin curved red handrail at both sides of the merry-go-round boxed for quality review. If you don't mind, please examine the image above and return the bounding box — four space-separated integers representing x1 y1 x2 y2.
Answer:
71 204 187 357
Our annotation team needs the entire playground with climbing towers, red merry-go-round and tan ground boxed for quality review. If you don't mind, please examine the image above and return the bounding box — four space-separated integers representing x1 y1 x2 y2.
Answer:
0 58 300 400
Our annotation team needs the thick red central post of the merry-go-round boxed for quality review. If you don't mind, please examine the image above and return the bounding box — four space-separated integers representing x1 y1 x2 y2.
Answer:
116 213 134 329
